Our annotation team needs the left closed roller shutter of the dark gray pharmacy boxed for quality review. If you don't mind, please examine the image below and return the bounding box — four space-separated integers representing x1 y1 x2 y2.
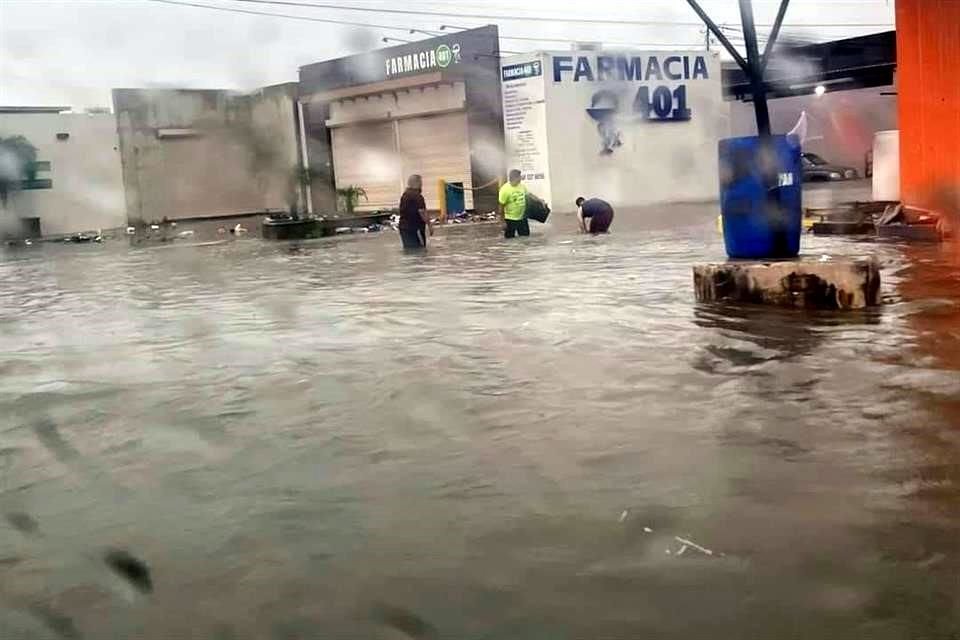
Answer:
331 122 402 211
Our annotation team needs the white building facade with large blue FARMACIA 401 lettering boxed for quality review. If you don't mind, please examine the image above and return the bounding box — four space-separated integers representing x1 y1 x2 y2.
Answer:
501 50 730 211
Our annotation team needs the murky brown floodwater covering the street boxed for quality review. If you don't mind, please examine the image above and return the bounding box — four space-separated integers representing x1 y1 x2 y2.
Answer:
0 216 960 640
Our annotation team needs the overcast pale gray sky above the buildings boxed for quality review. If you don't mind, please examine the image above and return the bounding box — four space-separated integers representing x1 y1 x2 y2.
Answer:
0 0 894 108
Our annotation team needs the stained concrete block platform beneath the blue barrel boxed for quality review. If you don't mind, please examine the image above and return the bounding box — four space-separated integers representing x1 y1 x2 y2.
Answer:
693 258 880 309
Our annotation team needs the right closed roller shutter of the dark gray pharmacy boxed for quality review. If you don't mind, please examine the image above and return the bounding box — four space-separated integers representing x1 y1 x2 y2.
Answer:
398 112 473 209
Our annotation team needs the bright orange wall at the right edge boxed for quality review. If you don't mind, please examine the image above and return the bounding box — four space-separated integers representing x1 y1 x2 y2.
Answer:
896 0 960 209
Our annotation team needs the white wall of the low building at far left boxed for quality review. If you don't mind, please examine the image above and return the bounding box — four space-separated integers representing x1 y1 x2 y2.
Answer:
0 113 127 236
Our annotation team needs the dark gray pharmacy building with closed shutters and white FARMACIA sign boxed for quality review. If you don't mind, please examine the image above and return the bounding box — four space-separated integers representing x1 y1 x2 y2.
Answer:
300 26 505 215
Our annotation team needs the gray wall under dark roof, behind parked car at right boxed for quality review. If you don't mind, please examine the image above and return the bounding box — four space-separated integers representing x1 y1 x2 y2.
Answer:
730 87 897 175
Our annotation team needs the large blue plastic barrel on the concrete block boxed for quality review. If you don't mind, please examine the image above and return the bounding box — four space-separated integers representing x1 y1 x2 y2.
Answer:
720 136 803 260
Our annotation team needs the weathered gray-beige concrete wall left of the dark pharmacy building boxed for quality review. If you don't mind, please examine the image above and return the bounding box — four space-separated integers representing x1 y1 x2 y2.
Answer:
113 83 298 223
